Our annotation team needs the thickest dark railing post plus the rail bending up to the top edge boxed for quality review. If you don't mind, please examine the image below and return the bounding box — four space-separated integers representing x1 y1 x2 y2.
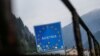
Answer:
62 0 83 56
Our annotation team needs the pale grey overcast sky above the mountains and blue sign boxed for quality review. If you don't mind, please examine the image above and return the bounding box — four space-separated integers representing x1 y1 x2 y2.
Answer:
12 0 100 34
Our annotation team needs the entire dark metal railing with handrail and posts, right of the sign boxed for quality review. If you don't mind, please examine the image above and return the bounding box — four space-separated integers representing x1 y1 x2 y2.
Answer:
62 0 100 56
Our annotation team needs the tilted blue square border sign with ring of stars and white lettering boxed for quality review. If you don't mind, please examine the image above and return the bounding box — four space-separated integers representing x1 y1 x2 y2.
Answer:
34 22 64 52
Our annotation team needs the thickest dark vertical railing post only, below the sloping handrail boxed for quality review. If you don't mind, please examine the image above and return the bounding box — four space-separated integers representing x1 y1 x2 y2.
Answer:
73 14 83 56
